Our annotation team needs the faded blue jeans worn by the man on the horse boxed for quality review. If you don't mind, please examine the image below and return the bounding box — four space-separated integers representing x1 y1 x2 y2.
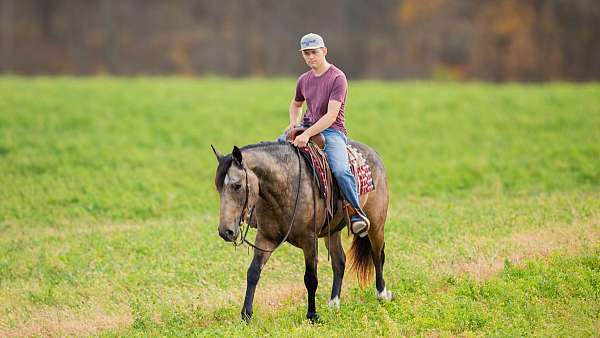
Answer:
277 128 362 212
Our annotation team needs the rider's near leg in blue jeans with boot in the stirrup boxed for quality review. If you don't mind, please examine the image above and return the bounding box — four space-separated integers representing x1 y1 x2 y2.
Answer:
322 129 368 235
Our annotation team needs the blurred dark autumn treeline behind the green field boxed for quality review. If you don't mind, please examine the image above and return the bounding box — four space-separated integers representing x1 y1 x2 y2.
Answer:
0 0 600 81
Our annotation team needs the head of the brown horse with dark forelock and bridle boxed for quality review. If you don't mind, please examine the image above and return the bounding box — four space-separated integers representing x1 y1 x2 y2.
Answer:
211 146 258 242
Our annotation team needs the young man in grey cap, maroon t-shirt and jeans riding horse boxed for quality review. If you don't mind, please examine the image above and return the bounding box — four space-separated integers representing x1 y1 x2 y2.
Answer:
278 33 369 237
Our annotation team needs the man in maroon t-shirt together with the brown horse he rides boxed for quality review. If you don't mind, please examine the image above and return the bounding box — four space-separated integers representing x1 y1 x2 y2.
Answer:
213 33 392 321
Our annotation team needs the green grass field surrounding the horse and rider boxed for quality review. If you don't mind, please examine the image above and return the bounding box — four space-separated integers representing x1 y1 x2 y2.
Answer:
0 77 600 337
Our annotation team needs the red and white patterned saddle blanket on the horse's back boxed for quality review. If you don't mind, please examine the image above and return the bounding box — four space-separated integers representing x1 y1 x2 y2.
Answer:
299 142 375 216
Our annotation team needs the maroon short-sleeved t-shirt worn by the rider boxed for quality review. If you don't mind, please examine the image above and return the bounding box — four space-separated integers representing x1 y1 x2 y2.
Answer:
295 65 348 134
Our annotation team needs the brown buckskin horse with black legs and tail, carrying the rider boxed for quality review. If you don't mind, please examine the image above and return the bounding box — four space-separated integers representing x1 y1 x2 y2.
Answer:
211 140 392 322
